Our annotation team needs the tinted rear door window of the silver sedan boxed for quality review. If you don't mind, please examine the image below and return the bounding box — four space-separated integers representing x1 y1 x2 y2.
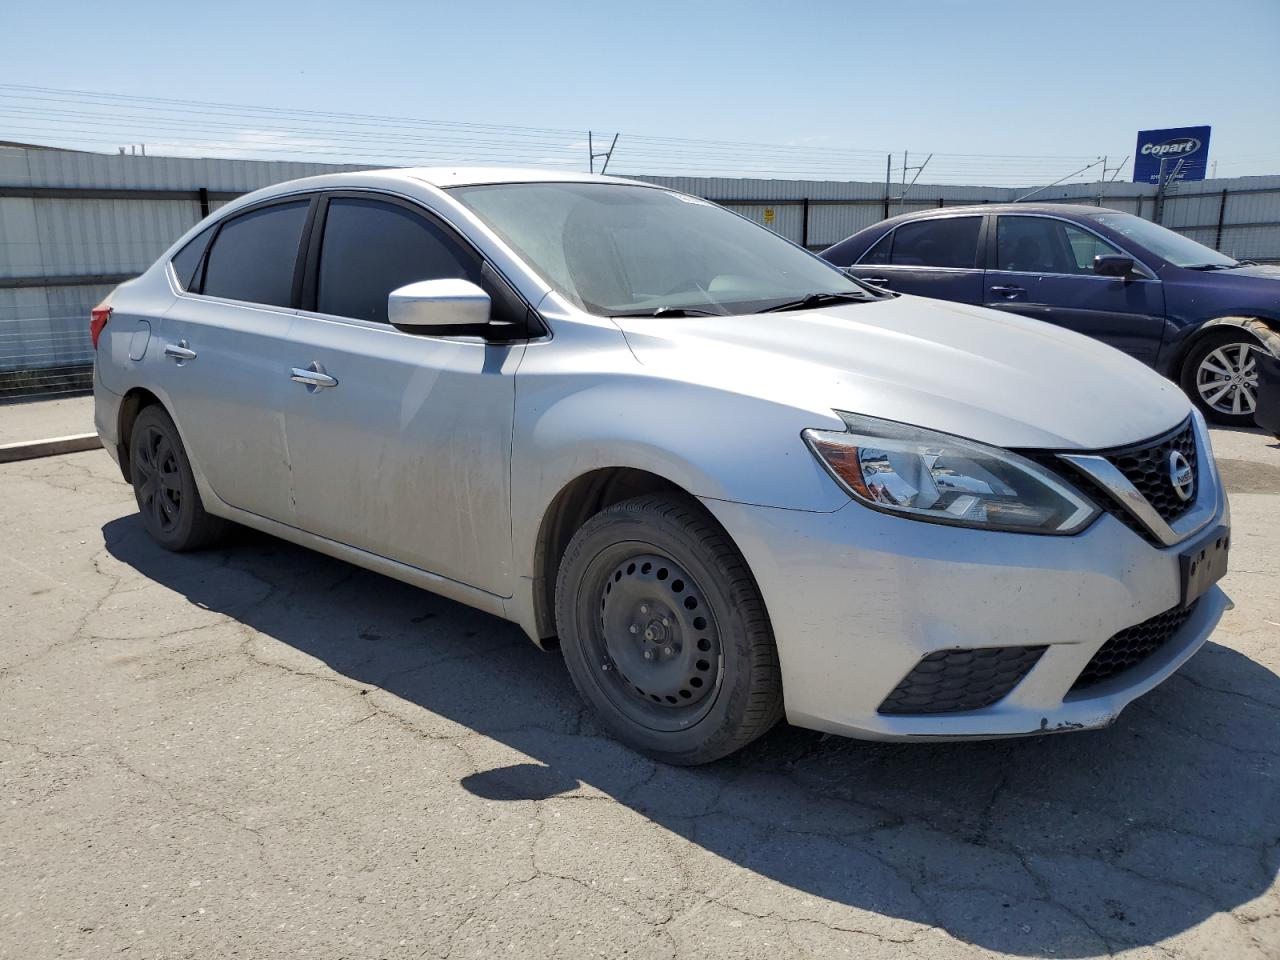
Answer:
204 200 311 307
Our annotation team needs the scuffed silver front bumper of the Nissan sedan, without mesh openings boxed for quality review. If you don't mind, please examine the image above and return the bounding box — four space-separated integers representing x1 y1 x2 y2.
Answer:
704 488 1229 740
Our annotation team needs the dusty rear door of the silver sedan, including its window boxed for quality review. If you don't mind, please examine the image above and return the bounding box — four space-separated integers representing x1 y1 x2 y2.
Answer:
148 197 312 524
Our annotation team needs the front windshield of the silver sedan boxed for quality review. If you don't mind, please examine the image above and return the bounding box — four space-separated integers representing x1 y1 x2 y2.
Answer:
449 183 870 316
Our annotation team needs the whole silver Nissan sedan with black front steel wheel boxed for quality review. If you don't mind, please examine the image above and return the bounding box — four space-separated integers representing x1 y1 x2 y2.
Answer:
91 169 1230 763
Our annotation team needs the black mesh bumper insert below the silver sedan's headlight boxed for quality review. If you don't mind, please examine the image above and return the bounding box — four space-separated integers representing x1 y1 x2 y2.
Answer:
879 646 1044 714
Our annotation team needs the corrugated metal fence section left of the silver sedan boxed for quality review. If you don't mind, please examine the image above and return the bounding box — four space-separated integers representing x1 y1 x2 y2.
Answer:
0 147 358 401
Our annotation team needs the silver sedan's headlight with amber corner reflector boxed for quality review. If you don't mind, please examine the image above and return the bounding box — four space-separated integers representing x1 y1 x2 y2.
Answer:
804 411 1098 534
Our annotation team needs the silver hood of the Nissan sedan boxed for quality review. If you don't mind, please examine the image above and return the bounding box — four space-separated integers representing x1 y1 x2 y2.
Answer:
616 296 1190 449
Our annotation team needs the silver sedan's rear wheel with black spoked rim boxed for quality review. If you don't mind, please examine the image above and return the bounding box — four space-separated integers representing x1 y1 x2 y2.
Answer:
129 404 228 553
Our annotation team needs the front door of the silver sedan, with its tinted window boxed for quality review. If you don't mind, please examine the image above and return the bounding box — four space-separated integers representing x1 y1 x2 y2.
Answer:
285 196 524 596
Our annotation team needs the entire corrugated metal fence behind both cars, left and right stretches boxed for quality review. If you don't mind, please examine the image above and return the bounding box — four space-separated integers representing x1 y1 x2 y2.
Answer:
0 147 1280 401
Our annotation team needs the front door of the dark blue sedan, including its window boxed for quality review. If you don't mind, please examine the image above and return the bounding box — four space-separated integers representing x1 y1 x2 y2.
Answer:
984 214 1165 365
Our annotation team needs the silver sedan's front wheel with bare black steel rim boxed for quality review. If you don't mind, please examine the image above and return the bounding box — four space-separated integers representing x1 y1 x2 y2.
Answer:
556 495 782 765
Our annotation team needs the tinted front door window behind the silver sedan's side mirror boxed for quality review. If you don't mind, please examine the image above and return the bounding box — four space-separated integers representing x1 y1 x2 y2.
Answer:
316 198 480 323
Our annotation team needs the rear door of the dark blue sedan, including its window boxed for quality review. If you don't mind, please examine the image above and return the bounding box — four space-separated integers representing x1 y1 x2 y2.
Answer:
849 214 984 303
